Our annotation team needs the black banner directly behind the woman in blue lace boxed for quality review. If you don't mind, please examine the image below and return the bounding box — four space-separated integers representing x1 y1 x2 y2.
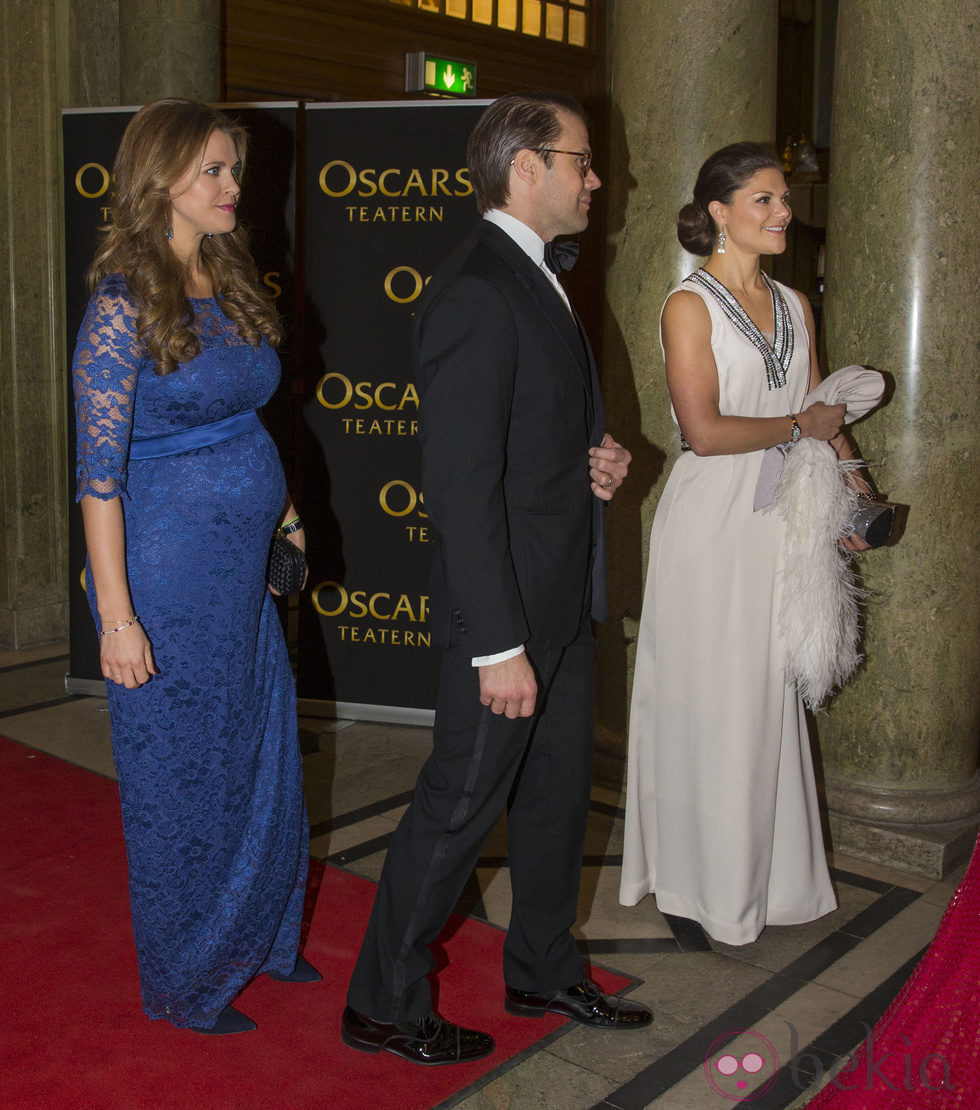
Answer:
62 103 297 694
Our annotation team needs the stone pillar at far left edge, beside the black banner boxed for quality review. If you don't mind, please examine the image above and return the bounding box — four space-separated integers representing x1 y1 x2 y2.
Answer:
0 0 68 647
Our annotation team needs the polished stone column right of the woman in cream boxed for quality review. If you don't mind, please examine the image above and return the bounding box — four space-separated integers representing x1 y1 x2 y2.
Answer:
818 0 980 876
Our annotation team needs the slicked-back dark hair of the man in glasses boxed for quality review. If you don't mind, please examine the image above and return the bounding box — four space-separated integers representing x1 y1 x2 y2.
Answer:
466 91 587 212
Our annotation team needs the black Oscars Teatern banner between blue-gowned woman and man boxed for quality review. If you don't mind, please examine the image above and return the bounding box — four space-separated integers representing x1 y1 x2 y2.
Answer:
299 101 486 719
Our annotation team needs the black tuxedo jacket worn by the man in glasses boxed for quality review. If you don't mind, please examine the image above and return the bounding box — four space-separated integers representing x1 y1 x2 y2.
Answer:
413 220 605 656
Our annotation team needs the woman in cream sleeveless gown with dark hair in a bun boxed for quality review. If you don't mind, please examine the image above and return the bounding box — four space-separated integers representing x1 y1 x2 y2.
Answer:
619 143 860 945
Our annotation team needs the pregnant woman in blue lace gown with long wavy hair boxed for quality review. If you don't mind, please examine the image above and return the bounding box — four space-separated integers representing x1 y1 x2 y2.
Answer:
74 100 319 1033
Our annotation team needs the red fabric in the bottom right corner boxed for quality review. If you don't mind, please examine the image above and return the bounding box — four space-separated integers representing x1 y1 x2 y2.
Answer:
807 840 980 1110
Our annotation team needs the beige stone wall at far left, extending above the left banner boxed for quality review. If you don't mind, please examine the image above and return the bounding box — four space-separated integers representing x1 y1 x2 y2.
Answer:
0 0 221 648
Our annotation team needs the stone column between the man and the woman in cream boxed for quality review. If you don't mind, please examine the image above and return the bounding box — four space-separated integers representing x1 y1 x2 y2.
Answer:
598 0 778 774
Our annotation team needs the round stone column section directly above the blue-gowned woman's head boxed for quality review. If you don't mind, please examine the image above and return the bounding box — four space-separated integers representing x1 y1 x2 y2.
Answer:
119 0 221 104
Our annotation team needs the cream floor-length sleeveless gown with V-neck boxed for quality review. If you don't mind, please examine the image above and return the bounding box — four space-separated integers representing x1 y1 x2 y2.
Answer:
619 275 837 945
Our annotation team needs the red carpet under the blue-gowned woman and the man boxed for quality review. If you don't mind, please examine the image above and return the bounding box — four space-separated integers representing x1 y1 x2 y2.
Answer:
0 738 629 1110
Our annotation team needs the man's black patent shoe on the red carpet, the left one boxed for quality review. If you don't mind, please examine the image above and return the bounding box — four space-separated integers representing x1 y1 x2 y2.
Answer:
341 1006 495 1067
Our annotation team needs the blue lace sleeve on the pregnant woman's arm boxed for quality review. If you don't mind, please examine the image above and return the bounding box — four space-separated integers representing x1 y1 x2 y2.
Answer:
72 279 144 501
